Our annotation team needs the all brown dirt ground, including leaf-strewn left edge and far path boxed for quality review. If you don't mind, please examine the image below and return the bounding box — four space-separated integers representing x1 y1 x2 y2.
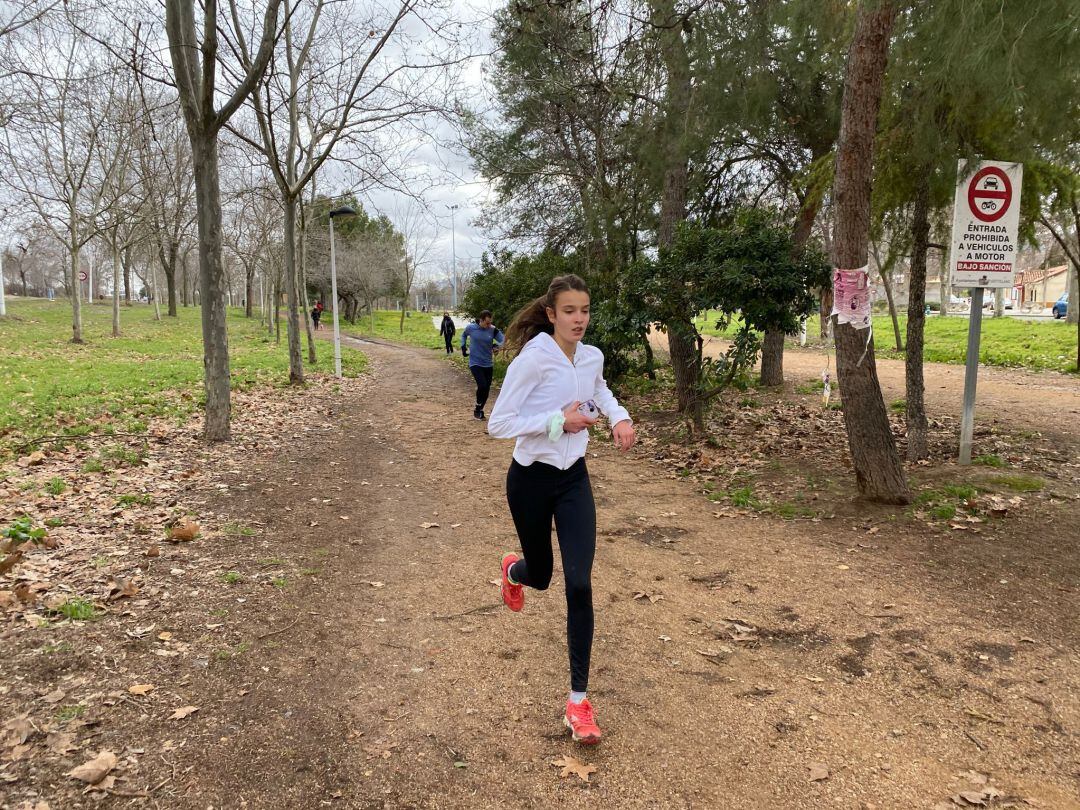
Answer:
0 332 1080 810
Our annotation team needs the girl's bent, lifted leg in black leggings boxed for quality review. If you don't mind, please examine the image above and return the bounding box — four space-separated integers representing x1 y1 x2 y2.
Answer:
507 461 557 591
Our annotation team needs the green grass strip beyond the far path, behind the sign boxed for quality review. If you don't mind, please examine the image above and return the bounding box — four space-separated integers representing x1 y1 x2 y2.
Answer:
696 312 1077 372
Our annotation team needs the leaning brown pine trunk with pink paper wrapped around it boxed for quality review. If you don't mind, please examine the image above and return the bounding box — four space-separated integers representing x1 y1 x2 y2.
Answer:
833 0 912 503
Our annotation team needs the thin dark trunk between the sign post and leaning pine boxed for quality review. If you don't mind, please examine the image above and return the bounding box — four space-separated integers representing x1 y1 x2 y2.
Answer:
904 173 931 461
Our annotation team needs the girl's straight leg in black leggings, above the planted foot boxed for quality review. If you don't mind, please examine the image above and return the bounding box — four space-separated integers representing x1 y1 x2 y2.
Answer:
555 459 596 692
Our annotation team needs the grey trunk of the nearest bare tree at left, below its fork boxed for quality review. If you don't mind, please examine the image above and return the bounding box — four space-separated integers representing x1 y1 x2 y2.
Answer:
191 138 231 442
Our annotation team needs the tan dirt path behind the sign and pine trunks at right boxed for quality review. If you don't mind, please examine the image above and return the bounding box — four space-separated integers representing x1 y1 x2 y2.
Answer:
682 335 1080 442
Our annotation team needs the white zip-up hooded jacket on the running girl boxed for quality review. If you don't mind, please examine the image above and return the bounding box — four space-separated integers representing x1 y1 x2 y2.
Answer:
487 332 630 470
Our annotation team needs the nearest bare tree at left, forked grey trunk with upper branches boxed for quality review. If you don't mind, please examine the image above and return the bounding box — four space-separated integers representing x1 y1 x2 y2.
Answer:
165 0 281 442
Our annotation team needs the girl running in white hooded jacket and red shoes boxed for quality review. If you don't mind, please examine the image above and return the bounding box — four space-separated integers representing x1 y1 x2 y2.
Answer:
487 274 635 745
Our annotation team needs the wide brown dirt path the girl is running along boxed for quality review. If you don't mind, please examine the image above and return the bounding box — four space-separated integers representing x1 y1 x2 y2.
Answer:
172 336 1080 809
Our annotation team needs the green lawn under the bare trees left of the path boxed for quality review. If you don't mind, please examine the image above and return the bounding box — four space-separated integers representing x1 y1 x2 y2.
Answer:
0 299 369 462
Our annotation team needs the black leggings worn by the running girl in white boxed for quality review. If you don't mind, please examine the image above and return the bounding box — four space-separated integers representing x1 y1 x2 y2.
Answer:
507 458 596 692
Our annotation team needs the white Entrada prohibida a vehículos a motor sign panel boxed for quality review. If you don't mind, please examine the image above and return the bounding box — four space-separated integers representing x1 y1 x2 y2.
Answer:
949 160 1024 288
